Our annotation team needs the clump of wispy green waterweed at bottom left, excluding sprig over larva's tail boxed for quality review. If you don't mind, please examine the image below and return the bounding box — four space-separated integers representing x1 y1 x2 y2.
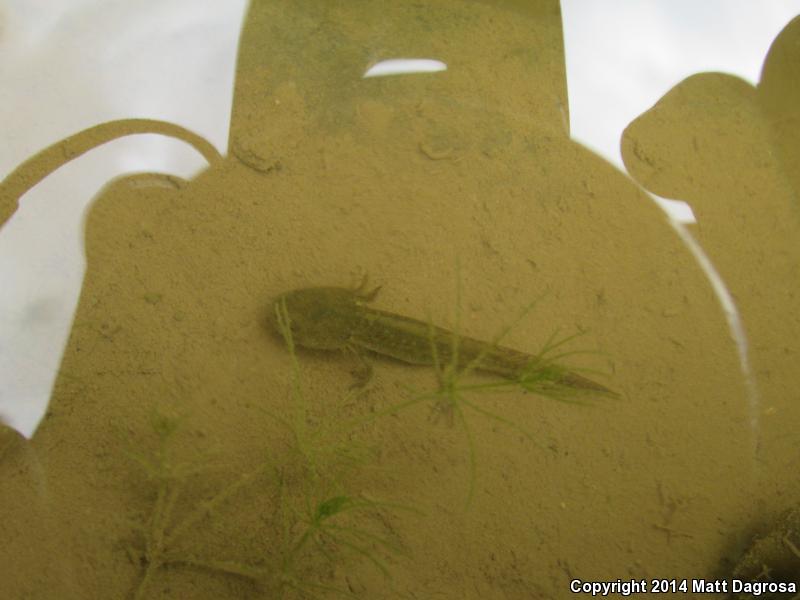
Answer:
123 304 419 600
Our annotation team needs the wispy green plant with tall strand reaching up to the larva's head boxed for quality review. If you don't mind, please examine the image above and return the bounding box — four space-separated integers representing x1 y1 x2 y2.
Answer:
244 303 420 598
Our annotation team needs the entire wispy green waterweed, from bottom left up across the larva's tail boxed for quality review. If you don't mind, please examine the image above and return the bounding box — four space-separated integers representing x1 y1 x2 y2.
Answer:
124 276 615 600
